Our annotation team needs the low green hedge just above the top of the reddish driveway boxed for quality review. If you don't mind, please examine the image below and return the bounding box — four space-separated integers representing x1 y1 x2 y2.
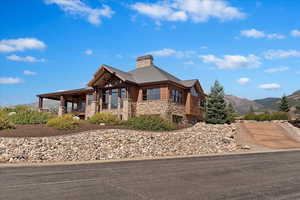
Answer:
244 112 289 121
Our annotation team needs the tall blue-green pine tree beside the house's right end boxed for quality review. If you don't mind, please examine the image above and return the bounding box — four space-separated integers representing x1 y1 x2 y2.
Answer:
205 81 228 124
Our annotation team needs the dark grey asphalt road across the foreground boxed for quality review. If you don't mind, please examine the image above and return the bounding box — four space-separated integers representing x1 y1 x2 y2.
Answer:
0 151 300 200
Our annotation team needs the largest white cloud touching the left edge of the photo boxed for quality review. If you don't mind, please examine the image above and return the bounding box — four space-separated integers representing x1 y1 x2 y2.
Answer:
0 38 46 53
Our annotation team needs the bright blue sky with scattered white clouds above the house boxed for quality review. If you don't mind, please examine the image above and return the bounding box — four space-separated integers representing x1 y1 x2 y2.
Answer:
0 0 300 106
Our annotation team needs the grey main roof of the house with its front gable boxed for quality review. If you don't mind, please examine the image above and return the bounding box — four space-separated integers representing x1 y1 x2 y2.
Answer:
88 65 198 88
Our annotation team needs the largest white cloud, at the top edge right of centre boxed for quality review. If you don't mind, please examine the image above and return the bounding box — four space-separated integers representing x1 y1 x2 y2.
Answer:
131 0 245 23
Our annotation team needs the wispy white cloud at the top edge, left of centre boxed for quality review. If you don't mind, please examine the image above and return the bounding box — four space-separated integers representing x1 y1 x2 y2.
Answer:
45 0 114 25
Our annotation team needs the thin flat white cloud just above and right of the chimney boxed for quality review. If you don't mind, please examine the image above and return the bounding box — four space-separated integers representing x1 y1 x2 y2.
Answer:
147 48 196 58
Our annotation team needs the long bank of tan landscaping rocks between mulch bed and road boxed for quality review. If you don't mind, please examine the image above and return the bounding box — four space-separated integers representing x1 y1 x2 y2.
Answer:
0 123 240 163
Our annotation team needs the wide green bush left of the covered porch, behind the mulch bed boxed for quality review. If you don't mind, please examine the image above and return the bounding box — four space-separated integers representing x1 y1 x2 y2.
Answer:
8 109 53 124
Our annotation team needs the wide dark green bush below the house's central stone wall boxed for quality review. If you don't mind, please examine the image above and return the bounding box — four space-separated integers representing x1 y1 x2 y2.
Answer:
122 115 176 131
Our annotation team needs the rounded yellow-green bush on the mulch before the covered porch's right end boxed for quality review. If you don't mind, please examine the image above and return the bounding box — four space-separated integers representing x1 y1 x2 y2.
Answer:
47 114 79 130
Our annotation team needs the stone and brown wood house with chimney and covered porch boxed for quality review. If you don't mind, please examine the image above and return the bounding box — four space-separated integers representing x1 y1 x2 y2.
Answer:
37 55 205 123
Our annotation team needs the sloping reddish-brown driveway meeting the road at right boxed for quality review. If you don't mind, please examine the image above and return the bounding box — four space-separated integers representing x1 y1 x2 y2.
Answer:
239 122 300 149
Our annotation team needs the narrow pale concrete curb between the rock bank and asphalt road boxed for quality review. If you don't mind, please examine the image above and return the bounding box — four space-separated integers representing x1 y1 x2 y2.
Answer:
0 148 300 169
